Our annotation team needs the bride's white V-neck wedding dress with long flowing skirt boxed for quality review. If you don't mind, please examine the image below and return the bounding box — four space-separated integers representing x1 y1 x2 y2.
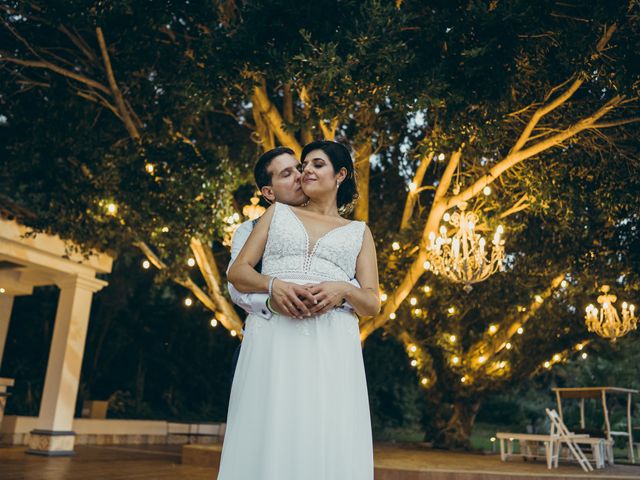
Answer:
218 203 373 480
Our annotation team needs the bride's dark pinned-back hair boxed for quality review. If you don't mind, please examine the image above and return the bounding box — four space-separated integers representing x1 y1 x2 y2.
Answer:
300 140 358 213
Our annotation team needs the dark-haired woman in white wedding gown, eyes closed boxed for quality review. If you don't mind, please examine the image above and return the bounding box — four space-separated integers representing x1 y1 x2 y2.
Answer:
218 141 380 480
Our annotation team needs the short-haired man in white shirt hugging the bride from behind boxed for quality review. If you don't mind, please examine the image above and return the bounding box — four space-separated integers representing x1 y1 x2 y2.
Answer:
227 147 360 378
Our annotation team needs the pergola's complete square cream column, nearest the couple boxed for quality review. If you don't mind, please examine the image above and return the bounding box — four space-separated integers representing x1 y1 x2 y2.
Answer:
27 276 107 456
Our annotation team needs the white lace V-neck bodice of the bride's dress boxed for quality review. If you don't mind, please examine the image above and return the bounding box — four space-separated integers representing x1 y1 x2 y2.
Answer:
262 203 365 282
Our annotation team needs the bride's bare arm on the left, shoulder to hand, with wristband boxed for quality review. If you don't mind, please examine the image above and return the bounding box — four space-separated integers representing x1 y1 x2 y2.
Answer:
227 204 315 318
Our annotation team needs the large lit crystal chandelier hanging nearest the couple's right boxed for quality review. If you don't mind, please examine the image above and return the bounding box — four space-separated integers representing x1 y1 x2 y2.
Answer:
424 204 504 292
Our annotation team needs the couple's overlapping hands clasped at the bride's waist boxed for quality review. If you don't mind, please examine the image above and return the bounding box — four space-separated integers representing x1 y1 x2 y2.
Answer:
271 278 351 319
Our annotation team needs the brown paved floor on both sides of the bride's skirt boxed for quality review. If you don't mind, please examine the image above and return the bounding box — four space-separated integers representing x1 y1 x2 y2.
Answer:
0 444 640 480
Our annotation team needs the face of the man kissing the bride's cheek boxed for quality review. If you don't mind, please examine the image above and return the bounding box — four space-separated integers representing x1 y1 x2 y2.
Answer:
262 153 307 205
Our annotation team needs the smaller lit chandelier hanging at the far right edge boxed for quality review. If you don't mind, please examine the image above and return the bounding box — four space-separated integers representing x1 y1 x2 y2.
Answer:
585 285 638 341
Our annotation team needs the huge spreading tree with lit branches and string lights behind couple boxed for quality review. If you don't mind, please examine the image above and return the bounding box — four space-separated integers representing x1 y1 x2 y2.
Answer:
0 0 640 446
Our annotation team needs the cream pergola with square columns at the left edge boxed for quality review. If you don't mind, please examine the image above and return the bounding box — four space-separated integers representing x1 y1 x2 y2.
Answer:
0 216 113 456
